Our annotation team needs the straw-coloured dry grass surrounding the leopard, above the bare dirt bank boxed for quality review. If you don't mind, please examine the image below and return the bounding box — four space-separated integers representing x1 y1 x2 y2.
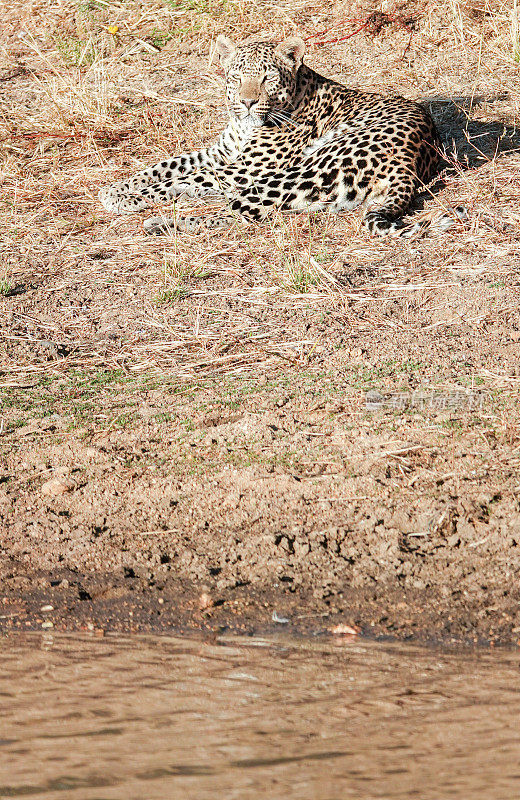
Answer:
0 0 520 385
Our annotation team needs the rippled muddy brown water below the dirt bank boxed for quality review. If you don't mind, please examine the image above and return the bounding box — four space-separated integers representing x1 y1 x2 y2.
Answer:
0 634 520 800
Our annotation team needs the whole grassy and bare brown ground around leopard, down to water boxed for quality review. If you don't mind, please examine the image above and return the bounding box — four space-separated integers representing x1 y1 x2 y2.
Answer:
0 0 520 642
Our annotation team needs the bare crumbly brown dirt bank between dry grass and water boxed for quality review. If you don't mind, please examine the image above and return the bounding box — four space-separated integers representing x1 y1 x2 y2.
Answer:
0 362 520 639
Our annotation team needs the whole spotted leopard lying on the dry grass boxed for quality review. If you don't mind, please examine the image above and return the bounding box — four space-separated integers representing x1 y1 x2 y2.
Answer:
99 34 465 236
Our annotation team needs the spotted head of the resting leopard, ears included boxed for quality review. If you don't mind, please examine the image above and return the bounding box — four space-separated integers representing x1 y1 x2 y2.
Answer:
217 35 305 125
